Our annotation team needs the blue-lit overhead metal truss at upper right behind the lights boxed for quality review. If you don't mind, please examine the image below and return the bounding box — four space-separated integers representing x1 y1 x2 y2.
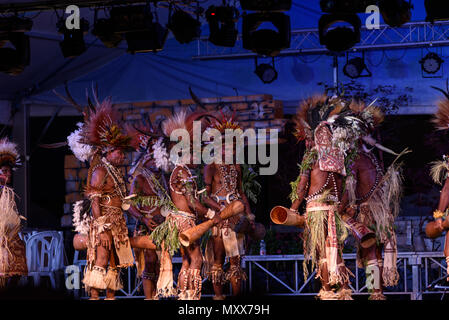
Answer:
192 21 449 60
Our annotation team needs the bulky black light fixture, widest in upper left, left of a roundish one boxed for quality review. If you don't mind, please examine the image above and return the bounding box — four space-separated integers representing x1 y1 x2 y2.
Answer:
110 6 168 54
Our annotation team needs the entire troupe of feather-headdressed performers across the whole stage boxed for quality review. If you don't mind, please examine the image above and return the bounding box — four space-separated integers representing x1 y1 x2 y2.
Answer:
0 87 449 300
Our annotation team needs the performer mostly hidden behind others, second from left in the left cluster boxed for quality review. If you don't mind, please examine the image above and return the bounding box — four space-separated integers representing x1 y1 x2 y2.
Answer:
129 123 176 300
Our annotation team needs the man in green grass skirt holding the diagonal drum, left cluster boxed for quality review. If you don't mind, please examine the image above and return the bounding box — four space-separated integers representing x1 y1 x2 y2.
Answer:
151 111 221 300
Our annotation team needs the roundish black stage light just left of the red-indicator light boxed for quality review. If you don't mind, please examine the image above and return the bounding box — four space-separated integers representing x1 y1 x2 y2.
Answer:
167 9 201 43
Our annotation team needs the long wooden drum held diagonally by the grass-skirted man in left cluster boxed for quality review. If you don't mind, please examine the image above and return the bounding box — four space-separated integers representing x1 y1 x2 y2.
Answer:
179 200 245 247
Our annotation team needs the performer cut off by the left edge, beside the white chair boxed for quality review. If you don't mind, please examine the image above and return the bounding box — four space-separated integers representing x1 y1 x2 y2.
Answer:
0 138 28 288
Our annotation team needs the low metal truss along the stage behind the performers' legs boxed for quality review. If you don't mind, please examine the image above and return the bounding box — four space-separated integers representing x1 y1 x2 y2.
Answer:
70 252 449 300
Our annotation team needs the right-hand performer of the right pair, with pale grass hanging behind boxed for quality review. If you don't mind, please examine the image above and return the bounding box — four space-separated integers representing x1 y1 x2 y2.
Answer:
333 102 408 300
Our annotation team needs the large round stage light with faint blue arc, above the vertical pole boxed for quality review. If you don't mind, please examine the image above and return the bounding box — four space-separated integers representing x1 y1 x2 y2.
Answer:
318 13 362 52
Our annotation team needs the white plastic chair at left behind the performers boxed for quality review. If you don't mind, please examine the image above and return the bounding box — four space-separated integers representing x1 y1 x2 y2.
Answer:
26 231 64 289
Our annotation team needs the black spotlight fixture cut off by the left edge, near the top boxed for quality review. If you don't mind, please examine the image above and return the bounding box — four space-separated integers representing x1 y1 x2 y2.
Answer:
0 16 33 75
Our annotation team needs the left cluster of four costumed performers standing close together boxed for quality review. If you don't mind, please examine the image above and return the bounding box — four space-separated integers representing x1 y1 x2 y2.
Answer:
68 96 255 300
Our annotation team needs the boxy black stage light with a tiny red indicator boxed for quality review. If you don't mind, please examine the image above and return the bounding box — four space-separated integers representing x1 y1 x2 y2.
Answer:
206 5 239 47
